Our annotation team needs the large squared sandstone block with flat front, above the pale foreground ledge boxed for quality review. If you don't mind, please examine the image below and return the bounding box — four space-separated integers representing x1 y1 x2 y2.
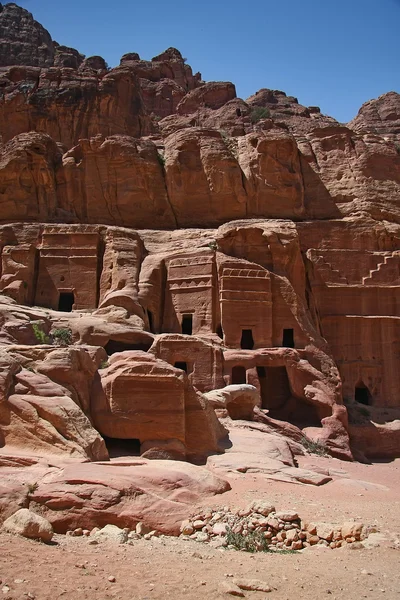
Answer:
91 352 226 461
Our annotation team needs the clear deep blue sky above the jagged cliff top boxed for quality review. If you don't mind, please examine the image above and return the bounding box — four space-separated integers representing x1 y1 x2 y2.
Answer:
14 0 400 122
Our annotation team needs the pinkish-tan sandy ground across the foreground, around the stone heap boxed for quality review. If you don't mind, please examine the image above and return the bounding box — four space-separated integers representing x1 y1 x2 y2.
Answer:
0 456 400 600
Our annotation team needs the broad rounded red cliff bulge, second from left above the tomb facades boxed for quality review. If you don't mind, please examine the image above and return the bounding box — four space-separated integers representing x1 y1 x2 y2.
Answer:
59 136 176 229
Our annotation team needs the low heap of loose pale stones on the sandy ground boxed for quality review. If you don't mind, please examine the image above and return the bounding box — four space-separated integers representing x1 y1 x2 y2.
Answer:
180 501 373 550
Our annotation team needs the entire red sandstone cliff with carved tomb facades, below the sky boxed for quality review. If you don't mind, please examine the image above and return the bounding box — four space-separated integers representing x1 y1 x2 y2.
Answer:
0 5 400 478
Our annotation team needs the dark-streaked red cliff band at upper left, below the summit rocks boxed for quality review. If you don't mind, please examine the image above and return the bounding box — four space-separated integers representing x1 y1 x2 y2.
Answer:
0 66 152 149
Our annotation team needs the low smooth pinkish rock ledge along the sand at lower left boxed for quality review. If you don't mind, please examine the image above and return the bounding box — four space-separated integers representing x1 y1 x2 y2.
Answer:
0 458 230 535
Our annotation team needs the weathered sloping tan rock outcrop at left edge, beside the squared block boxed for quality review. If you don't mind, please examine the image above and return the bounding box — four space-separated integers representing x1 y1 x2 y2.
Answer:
0 346 108 460
